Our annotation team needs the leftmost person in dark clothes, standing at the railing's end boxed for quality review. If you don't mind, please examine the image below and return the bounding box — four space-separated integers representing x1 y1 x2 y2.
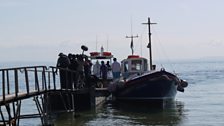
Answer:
56 53 70 89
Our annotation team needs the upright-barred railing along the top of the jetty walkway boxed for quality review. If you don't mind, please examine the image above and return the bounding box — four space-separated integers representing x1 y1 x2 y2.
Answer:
0 66 84 102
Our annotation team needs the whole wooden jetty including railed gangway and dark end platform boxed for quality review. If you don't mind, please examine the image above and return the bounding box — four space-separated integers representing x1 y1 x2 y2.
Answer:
0 66 110 126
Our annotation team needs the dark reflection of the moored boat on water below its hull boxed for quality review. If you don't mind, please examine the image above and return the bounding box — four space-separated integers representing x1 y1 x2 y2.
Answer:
109 101 184 126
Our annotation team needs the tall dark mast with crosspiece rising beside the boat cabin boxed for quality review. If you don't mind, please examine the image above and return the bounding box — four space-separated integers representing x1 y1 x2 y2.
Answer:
142 17 157 70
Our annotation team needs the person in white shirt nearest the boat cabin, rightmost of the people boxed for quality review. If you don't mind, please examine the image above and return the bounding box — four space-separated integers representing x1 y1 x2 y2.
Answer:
111 58 121 79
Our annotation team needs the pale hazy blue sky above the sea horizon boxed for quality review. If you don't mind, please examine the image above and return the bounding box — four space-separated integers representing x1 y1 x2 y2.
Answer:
0 0 224 62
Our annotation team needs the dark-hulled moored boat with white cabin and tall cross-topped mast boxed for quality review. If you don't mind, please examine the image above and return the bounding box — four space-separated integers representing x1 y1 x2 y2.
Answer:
108 18 188 102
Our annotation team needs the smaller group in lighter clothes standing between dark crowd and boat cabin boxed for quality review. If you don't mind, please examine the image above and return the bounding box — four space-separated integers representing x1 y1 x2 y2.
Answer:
93 58 121 80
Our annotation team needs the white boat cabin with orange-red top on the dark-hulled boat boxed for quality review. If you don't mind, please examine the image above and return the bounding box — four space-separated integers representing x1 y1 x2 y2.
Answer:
121 55 148 78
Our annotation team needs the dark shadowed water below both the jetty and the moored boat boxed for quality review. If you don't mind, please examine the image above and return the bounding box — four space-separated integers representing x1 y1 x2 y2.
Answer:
52 101 185 126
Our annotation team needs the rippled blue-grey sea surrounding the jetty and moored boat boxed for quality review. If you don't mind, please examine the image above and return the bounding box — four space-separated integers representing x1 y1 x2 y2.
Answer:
0 59 224 126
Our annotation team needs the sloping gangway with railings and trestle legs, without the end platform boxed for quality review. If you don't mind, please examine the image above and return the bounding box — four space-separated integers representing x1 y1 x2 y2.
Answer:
0 66 86 125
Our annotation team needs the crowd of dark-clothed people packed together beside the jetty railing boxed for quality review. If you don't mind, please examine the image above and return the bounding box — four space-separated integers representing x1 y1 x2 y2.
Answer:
56 53 92 89
